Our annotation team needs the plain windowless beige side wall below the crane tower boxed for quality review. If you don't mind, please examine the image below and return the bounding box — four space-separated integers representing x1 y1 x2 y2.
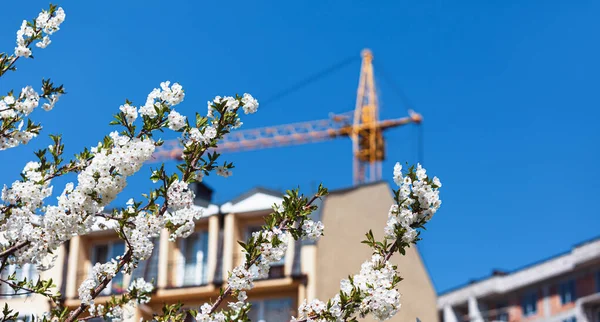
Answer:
316 182 438 322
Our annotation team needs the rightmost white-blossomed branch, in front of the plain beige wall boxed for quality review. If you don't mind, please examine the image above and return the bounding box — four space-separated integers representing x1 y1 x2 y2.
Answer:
294 163 442 322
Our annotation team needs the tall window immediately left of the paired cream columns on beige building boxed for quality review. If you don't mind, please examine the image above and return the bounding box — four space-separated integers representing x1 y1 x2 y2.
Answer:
177 231 208 286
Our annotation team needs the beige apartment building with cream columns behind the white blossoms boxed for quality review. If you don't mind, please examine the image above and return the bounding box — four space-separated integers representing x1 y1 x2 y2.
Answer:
0 182 438 322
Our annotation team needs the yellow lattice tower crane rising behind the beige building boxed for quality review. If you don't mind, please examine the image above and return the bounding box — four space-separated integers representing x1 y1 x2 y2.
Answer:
154 49 422 184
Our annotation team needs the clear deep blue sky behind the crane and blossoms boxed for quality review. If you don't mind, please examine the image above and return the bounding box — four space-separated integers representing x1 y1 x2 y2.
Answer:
0 0 600 291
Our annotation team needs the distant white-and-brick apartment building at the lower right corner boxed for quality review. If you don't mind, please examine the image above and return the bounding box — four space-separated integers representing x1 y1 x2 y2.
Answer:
438 238 600 322
